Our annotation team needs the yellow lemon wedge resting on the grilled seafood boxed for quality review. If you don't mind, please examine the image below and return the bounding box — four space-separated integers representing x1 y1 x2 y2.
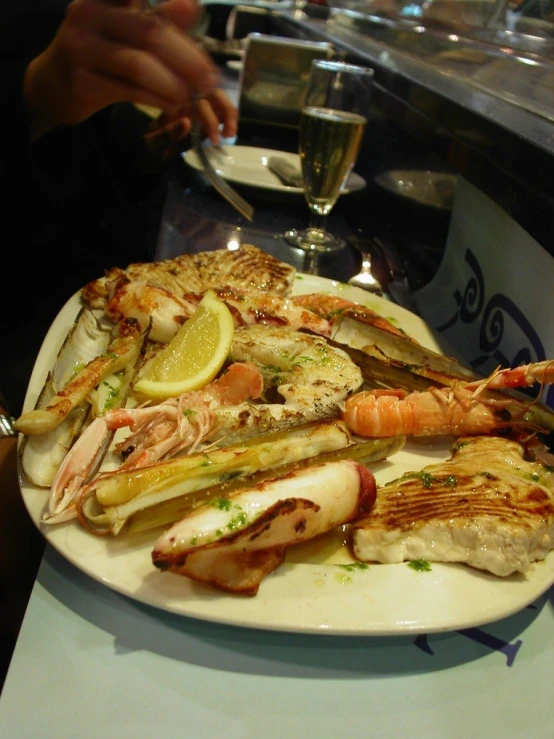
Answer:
133 290 234 400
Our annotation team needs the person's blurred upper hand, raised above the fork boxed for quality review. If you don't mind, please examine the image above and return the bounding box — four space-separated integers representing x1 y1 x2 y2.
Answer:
23 0 218 140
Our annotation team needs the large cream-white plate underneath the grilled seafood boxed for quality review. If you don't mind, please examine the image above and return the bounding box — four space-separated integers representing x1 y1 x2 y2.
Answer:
19 275 554 636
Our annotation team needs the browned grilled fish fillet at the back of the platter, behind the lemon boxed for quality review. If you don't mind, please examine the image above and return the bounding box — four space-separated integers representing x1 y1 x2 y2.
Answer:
81 244 296 308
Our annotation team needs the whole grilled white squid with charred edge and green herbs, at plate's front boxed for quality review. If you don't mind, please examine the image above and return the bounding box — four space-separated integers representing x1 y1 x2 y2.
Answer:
152 460 375 596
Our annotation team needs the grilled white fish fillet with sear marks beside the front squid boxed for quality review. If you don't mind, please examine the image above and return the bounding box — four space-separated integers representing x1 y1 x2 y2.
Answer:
353 436 554 576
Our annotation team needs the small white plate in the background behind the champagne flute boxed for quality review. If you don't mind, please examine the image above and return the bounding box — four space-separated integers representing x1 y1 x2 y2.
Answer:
182 145 366 195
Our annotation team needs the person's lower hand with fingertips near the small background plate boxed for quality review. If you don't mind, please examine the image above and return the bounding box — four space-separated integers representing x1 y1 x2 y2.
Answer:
140 89 238 168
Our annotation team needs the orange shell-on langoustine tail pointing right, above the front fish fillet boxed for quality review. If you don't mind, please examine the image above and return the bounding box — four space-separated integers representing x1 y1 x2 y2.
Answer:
342 360 554 437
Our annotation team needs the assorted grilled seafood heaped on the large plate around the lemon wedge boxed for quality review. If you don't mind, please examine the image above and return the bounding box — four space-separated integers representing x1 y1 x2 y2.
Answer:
16 245 554 631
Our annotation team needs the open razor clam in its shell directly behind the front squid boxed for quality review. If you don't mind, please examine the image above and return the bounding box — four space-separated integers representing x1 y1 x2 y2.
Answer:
80 420 403 534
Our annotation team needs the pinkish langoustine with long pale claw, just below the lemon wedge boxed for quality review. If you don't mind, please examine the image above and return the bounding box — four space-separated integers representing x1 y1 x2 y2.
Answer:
45 363 263 523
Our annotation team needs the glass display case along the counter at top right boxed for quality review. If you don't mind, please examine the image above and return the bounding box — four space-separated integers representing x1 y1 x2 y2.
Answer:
322 0 554 121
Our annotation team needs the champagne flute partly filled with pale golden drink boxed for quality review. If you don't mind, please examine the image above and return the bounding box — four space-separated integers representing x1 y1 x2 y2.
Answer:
285 59 373 252
